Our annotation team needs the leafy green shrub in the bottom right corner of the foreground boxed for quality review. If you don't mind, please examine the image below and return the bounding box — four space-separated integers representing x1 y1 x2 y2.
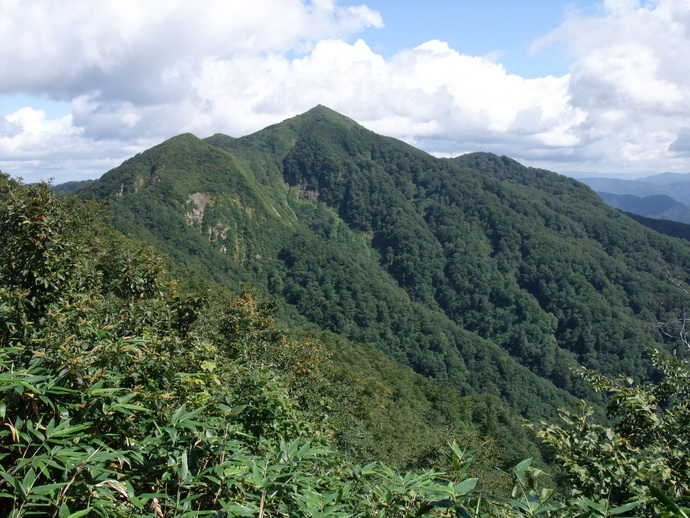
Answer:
538 350 690 516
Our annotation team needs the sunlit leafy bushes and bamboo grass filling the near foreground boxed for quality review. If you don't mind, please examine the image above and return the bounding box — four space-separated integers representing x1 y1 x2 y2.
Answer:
0 177 690 518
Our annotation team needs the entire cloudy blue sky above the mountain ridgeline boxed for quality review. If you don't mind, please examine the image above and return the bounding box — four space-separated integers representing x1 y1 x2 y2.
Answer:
0 0 690 182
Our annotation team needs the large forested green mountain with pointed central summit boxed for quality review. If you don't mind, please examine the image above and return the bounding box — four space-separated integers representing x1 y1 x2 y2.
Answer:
81 106 690 418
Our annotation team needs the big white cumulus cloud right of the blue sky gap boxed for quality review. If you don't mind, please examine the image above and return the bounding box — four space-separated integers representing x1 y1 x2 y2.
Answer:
535 0 690 172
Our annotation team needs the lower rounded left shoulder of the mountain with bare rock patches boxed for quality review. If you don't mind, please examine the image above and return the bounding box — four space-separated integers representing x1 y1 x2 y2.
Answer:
82 134 296 286
